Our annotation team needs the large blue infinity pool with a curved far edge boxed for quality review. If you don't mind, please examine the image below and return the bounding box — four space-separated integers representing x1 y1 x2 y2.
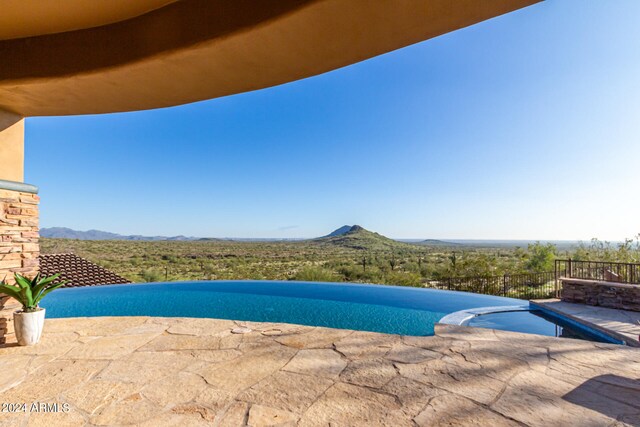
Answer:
42 281 522 335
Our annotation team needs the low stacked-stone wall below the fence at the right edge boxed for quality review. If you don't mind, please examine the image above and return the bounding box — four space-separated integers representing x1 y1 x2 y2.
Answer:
560 278 640 311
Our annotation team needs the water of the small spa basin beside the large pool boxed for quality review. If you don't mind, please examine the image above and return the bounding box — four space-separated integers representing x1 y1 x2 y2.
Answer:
466 310 621 344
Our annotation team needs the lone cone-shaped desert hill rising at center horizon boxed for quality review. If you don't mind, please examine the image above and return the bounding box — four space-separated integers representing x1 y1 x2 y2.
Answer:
310 225 411 250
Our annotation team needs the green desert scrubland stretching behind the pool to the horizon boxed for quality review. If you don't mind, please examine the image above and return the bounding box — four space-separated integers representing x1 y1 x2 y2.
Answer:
41 228 640 286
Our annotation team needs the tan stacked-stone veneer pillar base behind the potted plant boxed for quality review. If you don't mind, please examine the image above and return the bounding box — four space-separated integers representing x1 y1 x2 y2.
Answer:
0 185 40 344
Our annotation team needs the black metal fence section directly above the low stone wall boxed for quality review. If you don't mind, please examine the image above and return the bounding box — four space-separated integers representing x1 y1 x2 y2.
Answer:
555 259 640 284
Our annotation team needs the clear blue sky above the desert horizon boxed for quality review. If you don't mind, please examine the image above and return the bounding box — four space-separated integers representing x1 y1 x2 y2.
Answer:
26 0 640 239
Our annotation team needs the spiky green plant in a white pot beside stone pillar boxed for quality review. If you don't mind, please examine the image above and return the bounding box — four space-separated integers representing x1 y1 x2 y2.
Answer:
0 273 67 345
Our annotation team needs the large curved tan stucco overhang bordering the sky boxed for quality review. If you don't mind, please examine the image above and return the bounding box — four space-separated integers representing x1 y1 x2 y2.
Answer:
0 0 540 116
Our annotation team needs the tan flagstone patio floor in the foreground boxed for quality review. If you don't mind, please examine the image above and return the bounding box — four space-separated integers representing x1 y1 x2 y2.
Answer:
0 317 640 427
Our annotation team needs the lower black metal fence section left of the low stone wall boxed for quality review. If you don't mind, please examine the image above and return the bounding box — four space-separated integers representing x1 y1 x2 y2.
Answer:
427 271 558 300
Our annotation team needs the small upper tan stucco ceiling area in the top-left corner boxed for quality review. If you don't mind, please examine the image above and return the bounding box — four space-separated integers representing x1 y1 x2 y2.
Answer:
0 0 176 40
